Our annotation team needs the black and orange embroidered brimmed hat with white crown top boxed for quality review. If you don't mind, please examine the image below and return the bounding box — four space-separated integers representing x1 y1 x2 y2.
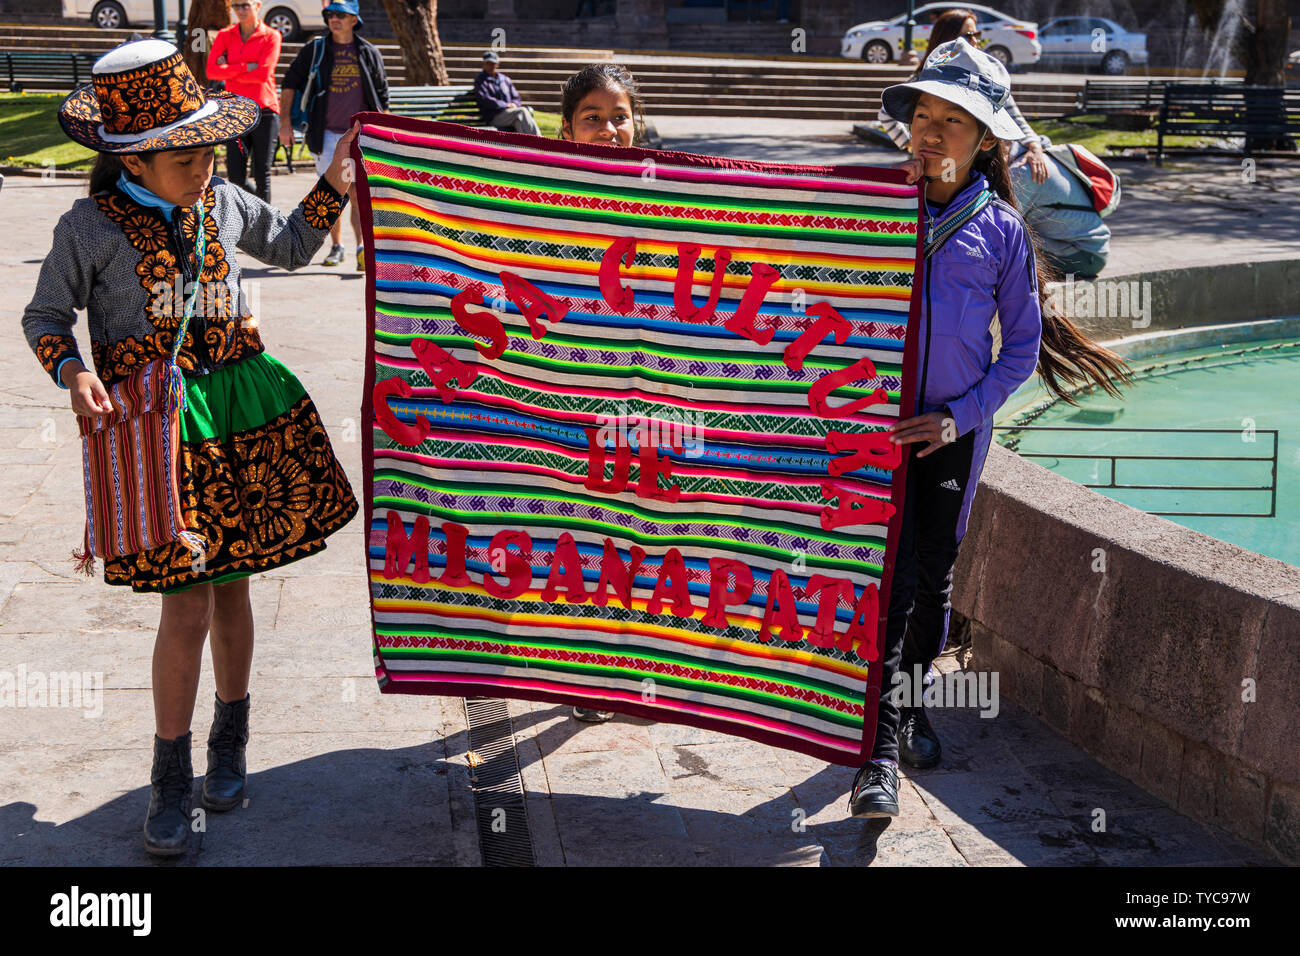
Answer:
59 39 261 153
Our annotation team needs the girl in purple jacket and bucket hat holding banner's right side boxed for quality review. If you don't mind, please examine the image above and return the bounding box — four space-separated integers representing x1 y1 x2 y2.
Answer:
849 39 1130 817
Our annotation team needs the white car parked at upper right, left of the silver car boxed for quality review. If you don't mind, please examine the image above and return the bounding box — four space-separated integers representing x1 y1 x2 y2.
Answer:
840 3 1041 66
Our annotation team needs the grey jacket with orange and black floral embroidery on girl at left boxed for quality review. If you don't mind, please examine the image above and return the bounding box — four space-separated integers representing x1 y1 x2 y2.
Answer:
22 177 346 385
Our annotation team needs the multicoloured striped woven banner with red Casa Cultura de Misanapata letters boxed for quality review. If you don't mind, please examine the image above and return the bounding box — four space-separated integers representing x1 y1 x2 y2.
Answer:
352 113 919 765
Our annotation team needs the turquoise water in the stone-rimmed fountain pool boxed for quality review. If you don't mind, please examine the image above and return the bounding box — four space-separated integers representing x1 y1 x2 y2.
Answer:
995 338 1300 566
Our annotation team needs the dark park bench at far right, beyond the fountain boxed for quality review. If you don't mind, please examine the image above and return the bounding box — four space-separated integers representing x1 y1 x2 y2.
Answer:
1156 83 1300 165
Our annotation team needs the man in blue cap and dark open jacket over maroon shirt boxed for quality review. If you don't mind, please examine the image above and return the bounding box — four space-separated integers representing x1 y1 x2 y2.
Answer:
280 0 389 272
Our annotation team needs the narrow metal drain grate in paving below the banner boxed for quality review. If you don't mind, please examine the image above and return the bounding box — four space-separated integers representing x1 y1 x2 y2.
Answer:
465 697 537 866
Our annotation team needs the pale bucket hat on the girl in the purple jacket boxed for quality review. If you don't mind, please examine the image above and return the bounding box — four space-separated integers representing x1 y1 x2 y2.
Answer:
880 38 1024 140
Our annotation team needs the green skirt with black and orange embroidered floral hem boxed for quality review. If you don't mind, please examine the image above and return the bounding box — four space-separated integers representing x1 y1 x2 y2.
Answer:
104 352 358 593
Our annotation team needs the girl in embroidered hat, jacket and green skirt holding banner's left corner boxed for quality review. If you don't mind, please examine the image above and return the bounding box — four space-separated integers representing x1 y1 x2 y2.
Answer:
22 39 358 856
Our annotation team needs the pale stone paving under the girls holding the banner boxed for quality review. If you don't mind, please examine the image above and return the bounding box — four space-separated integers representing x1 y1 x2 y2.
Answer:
0 136 1265 865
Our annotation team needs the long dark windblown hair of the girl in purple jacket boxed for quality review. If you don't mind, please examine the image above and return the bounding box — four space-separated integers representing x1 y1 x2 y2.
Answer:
971 130 1132 405
